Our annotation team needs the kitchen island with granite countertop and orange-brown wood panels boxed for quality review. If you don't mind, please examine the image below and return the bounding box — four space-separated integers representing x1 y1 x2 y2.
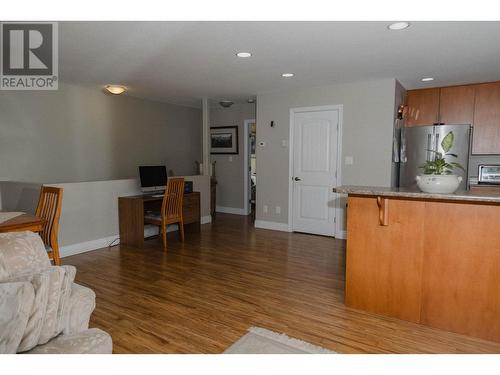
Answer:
334 186 500 342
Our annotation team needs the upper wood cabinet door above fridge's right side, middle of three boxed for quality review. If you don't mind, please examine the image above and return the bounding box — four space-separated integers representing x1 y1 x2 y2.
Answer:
439 86 475 125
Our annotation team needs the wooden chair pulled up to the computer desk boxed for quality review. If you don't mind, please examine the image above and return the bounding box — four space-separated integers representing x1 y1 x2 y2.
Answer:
144 178 184 250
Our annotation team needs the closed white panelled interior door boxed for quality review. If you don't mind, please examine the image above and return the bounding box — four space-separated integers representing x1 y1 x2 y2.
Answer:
292 110 339 236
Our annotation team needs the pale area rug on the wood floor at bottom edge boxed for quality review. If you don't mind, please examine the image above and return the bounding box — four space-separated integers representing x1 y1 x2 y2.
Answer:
224 327 335 354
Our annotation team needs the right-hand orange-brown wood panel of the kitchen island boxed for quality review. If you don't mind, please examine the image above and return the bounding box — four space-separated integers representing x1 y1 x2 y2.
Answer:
421 201 500 341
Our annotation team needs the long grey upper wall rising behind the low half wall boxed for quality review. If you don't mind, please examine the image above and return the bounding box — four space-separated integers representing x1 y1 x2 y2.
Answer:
0 84 201 182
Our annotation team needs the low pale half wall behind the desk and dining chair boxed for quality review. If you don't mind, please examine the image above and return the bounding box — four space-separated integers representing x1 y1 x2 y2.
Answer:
0 176 211 256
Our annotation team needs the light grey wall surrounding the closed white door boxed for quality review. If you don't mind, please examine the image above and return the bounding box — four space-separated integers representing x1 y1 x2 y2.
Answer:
256 79 396 229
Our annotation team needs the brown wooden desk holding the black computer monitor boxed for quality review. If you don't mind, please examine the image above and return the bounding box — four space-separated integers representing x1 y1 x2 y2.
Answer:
118 191 201 247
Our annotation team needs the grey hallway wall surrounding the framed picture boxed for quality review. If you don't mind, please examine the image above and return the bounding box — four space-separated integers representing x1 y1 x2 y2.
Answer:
210 103 259 211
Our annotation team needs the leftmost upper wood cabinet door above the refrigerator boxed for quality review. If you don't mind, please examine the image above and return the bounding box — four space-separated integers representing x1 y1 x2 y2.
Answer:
406 88 439 126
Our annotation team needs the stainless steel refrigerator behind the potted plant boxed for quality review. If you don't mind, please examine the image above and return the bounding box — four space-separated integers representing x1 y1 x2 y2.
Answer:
399 124 472 190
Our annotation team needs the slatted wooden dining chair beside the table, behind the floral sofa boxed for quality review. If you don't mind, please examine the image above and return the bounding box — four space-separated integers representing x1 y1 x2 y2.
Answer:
35 186 63 266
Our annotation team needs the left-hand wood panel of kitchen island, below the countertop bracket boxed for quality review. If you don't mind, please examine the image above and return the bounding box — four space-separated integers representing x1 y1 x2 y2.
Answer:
346 196 425 323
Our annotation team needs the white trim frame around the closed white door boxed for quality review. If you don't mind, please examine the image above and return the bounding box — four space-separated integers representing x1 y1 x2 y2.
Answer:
288 104 344 238
